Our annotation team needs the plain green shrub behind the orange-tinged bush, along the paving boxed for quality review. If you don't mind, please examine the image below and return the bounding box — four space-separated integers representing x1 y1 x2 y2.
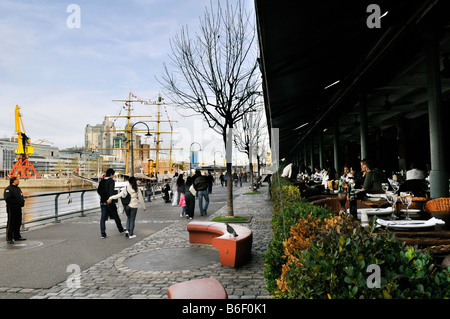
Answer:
264 174 334 293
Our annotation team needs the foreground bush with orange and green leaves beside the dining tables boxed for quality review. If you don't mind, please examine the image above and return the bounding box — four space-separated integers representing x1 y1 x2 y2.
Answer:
275 216 450 299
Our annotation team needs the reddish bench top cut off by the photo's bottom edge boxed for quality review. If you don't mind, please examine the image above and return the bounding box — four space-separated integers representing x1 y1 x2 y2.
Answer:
167 278 228 299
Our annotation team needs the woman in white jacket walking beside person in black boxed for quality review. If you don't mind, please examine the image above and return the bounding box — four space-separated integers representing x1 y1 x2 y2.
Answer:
107 176 146 238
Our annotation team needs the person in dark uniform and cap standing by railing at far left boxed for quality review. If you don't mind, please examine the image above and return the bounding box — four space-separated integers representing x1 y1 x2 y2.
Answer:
3 177 26 244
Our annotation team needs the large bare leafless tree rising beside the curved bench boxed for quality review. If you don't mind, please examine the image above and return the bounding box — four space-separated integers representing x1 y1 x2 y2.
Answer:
160 0 260 216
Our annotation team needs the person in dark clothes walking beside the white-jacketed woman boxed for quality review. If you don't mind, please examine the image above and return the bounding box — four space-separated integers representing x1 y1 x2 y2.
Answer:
97 168 125 238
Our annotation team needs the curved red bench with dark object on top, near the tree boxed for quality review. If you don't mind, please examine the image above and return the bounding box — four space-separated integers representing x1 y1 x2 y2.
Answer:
187 222 253 267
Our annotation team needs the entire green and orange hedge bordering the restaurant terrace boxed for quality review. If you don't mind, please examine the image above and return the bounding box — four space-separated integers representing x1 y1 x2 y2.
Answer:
264 175 450 299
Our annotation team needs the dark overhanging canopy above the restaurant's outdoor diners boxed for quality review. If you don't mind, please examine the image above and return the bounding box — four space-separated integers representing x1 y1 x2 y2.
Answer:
255 0 450 198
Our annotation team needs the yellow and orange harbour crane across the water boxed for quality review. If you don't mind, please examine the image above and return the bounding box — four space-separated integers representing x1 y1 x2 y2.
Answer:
8 105 40 178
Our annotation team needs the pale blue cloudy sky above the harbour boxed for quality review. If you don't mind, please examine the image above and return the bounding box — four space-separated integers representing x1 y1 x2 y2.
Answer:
0 0 260 168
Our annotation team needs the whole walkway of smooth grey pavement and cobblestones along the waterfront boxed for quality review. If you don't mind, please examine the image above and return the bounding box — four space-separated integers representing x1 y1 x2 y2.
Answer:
0 183 272 299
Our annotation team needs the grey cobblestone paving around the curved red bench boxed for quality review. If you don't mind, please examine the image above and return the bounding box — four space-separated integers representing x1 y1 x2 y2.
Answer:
31 184 272 299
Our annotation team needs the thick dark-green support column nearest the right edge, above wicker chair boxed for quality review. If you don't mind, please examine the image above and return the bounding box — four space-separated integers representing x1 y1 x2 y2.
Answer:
425 32 449 198
